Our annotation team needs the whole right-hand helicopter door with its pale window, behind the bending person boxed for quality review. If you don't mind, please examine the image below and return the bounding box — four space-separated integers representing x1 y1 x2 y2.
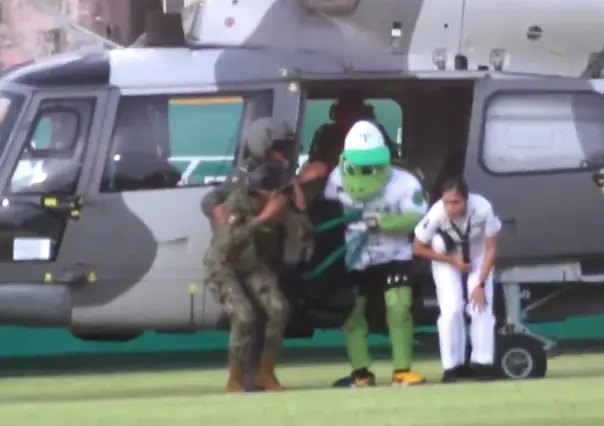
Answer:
465 76 604 265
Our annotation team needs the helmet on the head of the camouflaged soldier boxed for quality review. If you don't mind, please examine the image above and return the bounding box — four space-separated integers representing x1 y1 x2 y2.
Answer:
244 117 293 159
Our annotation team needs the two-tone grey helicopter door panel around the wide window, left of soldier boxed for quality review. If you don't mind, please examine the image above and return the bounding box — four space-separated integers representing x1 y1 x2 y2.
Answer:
65 82 292 331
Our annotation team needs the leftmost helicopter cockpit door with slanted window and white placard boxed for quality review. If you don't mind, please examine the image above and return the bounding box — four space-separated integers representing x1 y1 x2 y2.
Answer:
0 90 107 325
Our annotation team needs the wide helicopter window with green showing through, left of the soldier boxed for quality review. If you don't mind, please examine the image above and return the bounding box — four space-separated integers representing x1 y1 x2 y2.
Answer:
101 95 243 192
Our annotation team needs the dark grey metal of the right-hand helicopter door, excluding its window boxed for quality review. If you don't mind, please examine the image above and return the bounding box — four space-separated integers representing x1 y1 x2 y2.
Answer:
465 78 604 263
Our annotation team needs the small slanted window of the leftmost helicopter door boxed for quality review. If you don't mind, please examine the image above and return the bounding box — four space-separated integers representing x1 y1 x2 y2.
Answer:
10 99 94 194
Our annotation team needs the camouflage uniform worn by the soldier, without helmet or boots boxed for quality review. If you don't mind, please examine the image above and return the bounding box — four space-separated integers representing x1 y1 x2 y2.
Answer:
204 161 288 362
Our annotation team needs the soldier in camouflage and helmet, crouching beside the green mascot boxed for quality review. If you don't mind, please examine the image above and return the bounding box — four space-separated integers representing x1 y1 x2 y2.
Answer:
202 118 316 392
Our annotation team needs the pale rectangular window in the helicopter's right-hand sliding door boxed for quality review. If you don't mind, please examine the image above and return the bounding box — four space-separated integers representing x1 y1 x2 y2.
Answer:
482 93 604 174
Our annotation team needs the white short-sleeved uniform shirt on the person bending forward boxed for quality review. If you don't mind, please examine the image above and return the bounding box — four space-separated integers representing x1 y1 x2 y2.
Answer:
415 193 501 259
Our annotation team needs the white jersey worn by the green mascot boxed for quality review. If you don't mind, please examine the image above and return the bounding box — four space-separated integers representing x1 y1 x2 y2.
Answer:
324 168 428 270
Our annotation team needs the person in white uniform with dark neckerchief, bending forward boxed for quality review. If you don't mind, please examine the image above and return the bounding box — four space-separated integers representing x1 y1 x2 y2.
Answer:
413 178 501 382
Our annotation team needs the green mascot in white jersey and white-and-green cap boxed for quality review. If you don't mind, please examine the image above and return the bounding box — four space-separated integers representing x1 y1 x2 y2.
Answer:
324 120 427 387
